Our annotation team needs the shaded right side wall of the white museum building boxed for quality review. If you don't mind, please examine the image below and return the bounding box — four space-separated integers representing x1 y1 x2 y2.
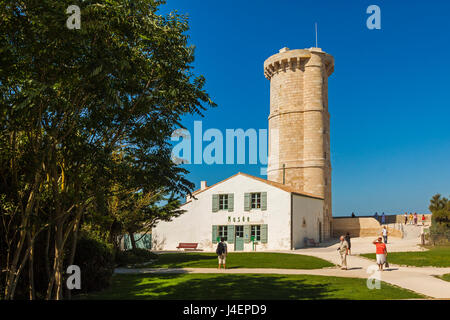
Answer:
292 194 324 249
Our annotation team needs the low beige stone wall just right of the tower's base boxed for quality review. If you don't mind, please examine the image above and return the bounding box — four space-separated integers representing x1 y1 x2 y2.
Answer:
333 217 403 238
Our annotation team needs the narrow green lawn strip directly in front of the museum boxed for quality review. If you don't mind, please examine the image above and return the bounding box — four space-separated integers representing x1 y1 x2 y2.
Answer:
144 252 334 269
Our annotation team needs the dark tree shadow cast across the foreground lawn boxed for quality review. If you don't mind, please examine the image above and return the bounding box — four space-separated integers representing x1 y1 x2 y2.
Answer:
85 274 337 300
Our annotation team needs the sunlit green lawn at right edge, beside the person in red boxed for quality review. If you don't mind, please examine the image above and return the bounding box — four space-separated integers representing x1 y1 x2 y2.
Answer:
361 246 450 267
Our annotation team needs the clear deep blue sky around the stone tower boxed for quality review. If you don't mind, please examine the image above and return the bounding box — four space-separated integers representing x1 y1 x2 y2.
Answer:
163 0 450 216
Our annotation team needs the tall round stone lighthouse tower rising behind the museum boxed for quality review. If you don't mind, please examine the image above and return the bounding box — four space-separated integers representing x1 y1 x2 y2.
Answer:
264 48 334 239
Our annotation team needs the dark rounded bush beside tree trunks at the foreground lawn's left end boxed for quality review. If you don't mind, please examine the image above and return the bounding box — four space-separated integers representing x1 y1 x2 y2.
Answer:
73 234 114 293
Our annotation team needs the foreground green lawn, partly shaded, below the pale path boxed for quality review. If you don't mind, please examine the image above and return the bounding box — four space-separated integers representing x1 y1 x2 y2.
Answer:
76 274 424 300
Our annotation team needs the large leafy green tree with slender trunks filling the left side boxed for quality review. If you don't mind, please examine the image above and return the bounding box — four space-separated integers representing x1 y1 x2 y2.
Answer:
0 0 214 299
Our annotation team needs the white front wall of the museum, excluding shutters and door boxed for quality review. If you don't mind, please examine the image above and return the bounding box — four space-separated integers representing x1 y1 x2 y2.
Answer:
152 175 291 251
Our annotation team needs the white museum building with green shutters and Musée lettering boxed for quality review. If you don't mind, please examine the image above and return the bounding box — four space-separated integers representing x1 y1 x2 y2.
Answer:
152 173 323 251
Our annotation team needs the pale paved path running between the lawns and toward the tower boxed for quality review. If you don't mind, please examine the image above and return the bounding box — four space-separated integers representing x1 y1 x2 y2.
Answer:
115 238 450 299
